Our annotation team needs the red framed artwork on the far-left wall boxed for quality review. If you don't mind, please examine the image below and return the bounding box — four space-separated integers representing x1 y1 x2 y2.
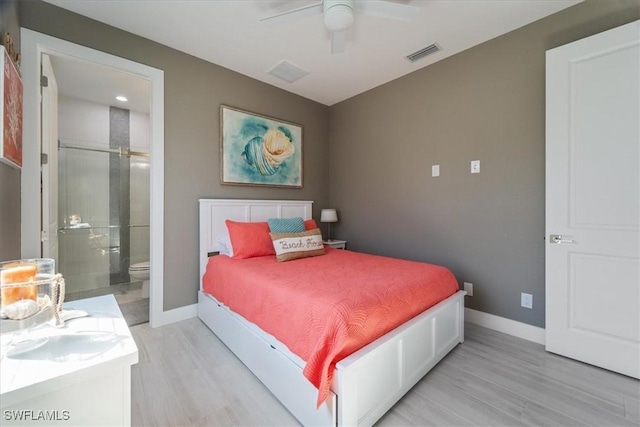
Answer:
0 46 22 168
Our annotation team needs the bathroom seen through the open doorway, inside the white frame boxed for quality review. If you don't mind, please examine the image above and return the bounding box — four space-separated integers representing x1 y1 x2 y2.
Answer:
42 54 151 325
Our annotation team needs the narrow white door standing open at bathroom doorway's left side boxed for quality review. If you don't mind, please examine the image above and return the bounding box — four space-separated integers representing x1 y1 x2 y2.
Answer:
41 54 58 260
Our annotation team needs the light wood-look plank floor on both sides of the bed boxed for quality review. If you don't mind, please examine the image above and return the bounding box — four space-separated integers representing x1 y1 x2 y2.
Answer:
131 319 640 427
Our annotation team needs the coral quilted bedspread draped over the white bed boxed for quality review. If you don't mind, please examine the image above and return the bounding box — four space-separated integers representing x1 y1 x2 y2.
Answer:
203 248 458 405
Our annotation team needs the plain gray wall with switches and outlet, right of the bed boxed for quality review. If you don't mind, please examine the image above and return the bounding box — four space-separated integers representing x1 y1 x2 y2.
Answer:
329 0 640 327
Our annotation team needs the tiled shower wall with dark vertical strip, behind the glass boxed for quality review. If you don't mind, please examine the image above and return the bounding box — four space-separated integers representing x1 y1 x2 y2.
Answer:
58 96 150 292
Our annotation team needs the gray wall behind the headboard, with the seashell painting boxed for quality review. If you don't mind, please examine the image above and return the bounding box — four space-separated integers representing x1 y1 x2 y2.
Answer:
19 1 329 310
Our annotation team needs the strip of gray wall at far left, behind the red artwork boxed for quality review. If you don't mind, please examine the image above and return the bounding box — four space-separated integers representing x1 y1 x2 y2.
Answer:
0 0 21 261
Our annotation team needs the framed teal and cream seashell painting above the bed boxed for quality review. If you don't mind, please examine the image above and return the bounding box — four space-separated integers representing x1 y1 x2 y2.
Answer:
220 105 302 188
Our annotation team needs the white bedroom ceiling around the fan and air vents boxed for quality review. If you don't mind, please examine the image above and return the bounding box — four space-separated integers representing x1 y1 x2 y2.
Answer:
45 0 582 105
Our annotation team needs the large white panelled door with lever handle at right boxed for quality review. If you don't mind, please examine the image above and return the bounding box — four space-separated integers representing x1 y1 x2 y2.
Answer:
546 21 640 378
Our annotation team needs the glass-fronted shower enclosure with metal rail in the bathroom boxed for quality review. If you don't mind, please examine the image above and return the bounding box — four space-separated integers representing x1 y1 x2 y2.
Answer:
58 103 150 300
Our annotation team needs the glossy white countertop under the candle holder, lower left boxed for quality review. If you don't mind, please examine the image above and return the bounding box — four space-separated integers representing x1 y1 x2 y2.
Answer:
0 295 138 407
